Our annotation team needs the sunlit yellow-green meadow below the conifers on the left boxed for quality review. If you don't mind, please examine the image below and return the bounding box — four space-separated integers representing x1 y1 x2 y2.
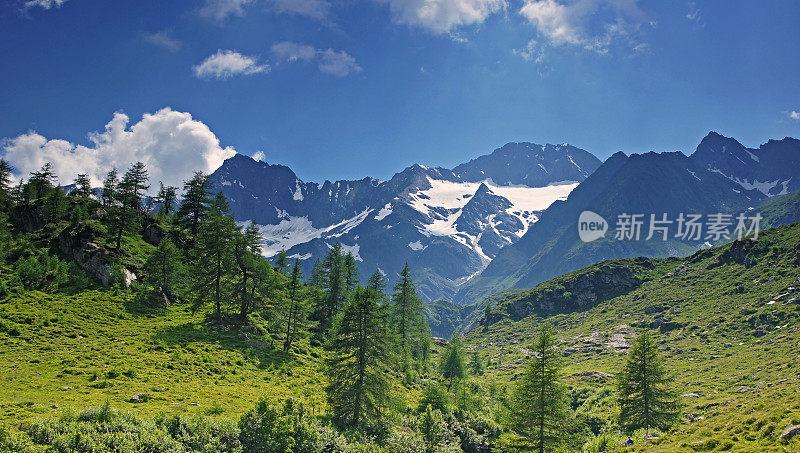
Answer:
0 290 324 424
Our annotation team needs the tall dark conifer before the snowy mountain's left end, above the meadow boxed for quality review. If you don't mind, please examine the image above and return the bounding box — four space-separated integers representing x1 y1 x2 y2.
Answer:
192 192 236 319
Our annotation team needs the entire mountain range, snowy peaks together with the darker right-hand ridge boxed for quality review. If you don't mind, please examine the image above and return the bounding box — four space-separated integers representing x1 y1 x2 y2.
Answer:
210 132 800 305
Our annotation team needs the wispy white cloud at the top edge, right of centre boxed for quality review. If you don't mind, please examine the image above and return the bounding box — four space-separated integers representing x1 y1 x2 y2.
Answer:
519 0 646 54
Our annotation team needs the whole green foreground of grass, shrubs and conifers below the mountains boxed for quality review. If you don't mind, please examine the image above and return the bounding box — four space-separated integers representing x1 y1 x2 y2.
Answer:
0 156 800 452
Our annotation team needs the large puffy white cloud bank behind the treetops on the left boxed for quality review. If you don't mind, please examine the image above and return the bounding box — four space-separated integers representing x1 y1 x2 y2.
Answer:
2 107 236 187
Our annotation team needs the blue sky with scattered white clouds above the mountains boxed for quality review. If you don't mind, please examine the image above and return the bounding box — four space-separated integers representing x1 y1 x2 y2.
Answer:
0 0 800 187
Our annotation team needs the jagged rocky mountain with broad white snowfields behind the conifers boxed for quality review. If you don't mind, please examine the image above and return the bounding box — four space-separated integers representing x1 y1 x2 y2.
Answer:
210 143 600 301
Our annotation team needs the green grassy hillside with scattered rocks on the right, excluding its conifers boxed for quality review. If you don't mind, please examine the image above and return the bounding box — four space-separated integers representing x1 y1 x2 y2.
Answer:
466 223 800 451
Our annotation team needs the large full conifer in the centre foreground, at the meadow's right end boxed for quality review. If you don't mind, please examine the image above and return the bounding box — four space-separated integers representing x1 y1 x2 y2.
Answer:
326 288 390 428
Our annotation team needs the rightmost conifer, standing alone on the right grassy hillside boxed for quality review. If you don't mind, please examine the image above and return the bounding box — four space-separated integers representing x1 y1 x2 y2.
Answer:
617 331 679 431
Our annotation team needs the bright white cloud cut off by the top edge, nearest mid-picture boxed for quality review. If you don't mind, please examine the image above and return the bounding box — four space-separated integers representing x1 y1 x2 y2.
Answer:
386 0 507 34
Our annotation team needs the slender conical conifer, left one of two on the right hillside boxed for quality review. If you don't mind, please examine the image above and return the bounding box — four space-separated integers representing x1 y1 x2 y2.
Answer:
511 326 568 452
